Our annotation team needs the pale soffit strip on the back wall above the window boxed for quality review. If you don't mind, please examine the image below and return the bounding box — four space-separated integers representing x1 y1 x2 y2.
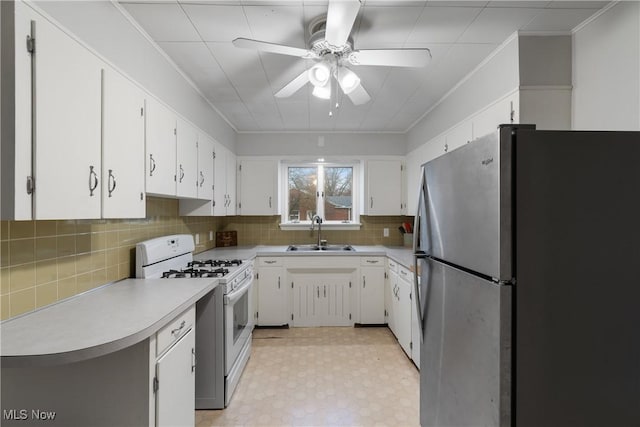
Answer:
236 132 407 157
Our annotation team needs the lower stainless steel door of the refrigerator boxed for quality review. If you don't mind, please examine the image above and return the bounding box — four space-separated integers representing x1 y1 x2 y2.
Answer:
418 258 511 427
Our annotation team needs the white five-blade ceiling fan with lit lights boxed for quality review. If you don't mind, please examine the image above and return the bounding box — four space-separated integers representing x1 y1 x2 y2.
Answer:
233 0 431 106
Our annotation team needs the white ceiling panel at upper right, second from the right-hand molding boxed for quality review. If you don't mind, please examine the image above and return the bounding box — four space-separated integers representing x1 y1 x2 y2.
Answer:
458 8 542 44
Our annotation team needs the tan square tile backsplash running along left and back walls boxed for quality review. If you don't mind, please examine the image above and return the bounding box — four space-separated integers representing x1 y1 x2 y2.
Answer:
0 201 407 320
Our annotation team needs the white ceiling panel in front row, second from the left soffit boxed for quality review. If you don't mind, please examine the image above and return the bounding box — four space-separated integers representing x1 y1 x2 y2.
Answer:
182 4 251 42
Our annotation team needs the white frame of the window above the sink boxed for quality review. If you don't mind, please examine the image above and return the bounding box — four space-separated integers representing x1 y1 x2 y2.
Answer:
280 160 364 230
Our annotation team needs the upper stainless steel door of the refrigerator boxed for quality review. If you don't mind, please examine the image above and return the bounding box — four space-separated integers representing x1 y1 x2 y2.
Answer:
421 129 513 281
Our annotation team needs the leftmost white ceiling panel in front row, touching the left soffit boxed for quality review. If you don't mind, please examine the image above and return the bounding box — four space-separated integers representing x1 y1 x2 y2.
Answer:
123 3 200 42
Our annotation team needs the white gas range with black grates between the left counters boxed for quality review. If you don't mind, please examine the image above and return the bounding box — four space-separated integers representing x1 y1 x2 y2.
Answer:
136 234 254 409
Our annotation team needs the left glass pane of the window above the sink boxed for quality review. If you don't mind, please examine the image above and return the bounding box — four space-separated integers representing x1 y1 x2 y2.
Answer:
288 167 318 222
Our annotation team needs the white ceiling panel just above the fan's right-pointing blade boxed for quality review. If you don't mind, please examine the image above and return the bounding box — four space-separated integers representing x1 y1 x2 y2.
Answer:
354 6 423 49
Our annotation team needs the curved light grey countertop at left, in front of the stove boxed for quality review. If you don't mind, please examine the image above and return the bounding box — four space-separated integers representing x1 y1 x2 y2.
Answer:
0 279 218 367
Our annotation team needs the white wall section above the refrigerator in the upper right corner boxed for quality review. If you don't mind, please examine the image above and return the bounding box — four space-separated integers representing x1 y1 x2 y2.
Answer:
572 1 640 131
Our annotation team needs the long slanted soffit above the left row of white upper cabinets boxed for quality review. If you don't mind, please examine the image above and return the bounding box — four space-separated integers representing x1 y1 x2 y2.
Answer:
34 1 236 152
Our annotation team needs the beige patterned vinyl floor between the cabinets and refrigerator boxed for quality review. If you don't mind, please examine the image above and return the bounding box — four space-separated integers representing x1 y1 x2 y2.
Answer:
196 327 420 427
